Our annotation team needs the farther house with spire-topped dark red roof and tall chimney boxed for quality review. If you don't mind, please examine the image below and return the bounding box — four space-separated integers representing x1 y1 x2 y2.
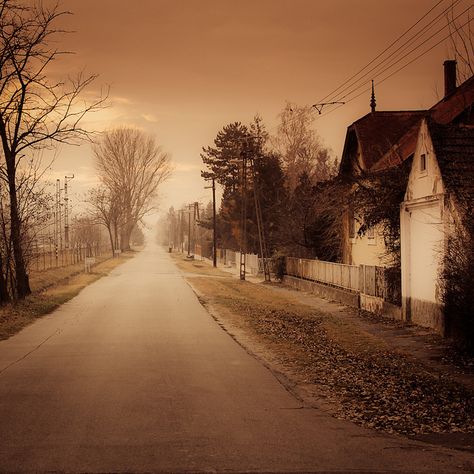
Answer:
339 60 474 266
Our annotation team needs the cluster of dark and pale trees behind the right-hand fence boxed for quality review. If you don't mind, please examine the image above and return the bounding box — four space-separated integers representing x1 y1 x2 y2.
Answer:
196 103 342 261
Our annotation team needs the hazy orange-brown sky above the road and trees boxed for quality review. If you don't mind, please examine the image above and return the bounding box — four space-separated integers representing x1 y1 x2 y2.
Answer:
52 0 469 218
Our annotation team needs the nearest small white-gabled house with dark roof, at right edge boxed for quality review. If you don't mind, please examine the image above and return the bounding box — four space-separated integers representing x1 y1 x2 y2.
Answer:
400 119 474 334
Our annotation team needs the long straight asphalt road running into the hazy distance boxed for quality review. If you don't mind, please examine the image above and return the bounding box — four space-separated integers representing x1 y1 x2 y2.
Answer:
0 245 474 473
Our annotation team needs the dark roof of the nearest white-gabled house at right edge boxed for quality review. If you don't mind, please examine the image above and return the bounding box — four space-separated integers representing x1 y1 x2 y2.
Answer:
429 121 474 211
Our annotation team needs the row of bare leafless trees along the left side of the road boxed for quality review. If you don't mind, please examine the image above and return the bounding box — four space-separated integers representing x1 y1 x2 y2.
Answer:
0 0 170 304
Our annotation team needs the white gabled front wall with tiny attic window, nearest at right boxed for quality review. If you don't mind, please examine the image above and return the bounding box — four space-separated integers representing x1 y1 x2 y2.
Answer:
400 123 446 332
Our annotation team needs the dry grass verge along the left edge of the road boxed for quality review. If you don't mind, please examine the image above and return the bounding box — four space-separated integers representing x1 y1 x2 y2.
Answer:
0 251 135 340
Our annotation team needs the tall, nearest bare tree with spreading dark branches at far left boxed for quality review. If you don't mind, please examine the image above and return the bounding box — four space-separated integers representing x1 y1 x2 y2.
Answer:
0 0 105 298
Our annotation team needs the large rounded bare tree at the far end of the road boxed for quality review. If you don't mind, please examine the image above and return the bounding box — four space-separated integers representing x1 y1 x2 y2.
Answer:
94 127 171 250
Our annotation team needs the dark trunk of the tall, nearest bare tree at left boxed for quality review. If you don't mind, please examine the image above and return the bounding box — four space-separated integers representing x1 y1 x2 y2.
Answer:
5 154 31 298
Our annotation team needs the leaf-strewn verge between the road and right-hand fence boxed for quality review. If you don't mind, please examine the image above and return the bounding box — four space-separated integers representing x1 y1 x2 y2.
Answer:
176 262 474 435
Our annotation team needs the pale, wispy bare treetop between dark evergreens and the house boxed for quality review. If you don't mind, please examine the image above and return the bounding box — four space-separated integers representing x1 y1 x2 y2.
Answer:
272 103 337 193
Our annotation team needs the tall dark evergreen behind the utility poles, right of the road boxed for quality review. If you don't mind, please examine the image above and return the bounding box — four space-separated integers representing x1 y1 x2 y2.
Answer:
201 116 284 253
